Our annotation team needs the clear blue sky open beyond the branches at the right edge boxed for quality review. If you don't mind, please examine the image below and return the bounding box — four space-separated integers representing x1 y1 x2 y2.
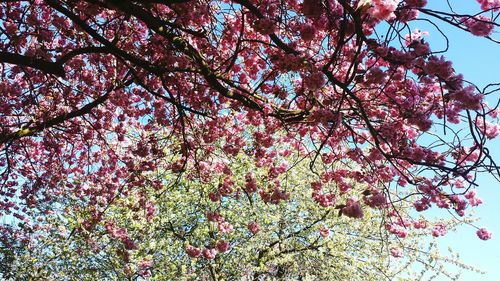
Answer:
414 0 500 281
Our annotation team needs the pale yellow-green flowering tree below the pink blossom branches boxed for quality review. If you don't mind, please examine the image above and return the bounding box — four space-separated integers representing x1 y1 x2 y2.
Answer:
0 149 478 280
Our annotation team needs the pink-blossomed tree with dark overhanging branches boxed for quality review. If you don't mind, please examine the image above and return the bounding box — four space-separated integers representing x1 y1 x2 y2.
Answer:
0 0 500 255
